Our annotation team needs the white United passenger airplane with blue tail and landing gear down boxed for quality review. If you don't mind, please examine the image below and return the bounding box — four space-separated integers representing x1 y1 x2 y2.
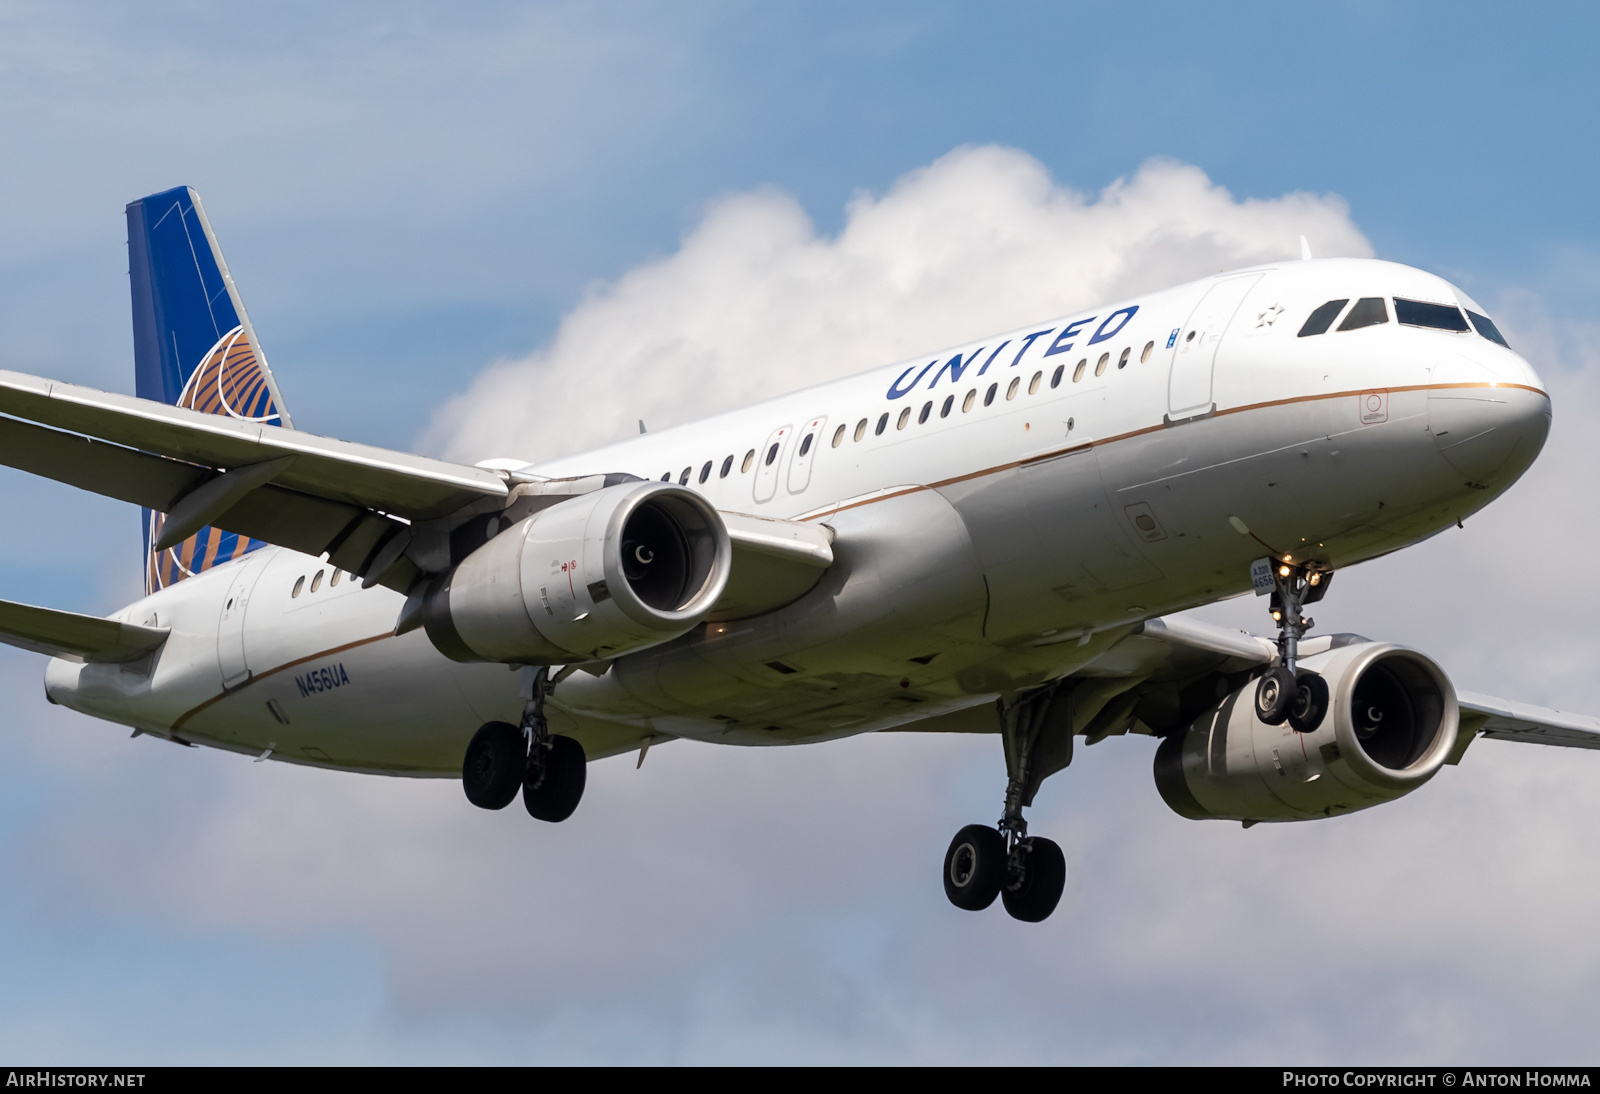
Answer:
0 187 1600 921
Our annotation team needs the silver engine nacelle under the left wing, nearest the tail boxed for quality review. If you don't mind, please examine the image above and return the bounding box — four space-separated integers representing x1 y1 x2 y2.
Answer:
422 483 733 664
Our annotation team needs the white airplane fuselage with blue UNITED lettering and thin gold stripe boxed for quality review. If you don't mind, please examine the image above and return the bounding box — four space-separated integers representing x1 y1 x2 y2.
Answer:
46 259 1550 774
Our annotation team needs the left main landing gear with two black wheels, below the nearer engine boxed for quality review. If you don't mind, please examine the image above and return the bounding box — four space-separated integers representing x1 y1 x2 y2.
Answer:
461 669 589 821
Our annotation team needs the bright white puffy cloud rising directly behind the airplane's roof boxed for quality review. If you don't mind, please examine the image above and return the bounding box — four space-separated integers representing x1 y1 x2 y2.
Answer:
422 147 1371 461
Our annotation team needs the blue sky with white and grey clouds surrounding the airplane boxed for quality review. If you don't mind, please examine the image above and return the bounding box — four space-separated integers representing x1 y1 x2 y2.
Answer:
0 2 1600 1064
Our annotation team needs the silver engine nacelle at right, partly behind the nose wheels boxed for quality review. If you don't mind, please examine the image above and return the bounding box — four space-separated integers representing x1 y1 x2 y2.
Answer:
1155 641 1461 822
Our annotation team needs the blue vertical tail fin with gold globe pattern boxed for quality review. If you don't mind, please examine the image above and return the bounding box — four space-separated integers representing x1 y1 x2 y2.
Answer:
128 186 291 593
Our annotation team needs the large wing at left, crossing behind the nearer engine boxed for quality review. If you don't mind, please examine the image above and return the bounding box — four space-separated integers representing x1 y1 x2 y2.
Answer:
0 371 834 619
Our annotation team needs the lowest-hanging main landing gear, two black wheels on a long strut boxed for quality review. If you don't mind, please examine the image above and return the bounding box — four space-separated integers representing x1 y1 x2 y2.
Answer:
944 686 1072 923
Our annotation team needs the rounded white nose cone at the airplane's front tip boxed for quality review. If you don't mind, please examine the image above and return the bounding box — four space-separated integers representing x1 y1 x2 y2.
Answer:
1427 353 1550 488
